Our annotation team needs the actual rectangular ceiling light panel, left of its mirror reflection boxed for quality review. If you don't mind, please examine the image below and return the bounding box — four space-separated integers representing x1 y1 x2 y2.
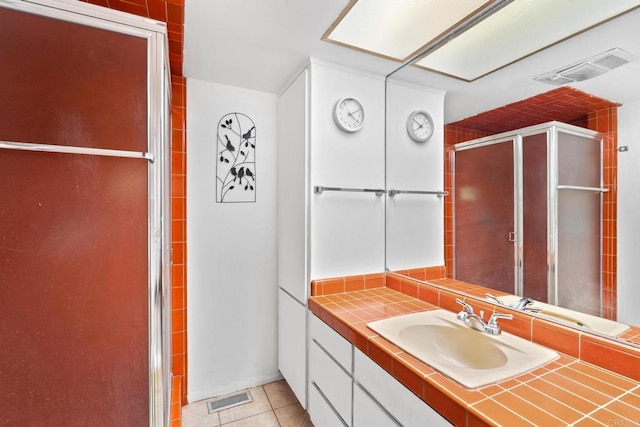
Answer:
322 0 493 62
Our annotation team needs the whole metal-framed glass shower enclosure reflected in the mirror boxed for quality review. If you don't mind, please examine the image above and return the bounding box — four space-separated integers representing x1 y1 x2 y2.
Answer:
454 122 606 315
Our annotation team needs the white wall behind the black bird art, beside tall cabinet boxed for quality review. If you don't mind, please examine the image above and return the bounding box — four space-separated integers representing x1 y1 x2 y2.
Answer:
187 79 280 402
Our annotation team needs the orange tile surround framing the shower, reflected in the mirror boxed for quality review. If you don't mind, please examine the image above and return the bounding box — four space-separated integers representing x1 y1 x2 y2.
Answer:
444 87 619 319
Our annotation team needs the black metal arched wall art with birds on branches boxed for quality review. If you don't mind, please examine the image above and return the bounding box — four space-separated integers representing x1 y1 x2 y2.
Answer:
216 113 256 203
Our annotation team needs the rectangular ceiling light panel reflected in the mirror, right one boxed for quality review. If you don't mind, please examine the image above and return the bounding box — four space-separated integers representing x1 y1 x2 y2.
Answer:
416 0 640 81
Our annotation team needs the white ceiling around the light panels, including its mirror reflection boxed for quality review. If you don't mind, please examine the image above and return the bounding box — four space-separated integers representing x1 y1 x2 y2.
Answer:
184 0 640 123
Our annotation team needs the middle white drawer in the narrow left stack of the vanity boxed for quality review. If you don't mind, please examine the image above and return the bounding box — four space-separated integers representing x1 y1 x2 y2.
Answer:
309 341 353 424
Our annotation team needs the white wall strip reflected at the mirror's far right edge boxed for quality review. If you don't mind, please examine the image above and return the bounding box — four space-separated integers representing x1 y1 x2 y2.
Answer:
618 100 640 325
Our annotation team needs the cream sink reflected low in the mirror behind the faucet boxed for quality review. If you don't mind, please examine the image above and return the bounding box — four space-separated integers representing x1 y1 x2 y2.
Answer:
498 295 629 336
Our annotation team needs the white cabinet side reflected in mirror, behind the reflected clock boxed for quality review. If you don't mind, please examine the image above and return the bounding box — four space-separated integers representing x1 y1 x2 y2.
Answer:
387 80 444 270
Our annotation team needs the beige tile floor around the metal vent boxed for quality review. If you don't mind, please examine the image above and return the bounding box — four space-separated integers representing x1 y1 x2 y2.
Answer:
182 380 313 427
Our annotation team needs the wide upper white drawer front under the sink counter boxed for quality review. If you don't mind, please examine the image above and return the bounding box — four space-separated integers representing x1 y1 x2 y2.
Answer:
353 349 452 427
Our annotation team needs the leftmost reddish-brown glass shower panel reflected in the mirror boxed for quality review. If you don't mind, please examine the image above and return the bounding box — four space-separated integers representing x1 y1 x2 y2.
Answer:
454 140 515 293
